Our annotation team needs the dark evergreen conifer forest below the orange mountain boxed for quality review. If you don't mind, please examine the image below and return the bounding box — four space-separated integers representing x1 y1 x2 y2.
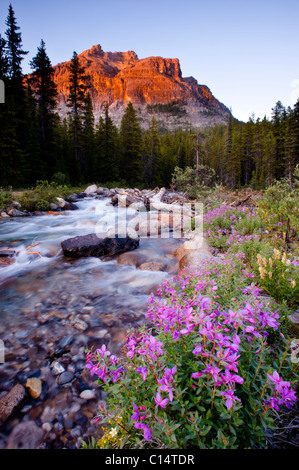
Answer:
0 5 299 188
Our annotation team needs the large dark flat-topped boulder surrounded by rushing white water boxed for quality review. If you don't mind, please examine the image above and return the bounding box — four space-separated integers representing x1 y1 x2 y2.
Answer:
61 233 139 258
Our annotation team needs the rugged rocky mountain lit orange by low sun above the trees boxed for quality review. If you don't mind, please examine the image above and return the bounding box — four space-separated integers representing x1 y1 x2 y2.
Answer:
54 45 230 128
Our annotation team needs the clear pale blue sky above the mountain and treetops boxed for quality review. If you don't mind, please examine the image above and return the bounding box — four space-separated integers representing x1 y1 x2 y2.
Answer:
0 0 299 121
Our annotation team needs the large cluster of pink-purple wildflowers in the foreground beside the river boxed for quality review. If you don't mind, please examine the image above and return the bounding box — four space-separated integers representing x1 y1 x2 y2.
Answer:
86 248 296 441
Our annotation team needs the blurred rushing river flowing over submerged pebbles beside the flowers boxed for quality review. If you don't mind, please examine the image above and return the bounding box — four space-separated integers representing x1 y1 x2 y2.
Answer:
0 197 183 448
